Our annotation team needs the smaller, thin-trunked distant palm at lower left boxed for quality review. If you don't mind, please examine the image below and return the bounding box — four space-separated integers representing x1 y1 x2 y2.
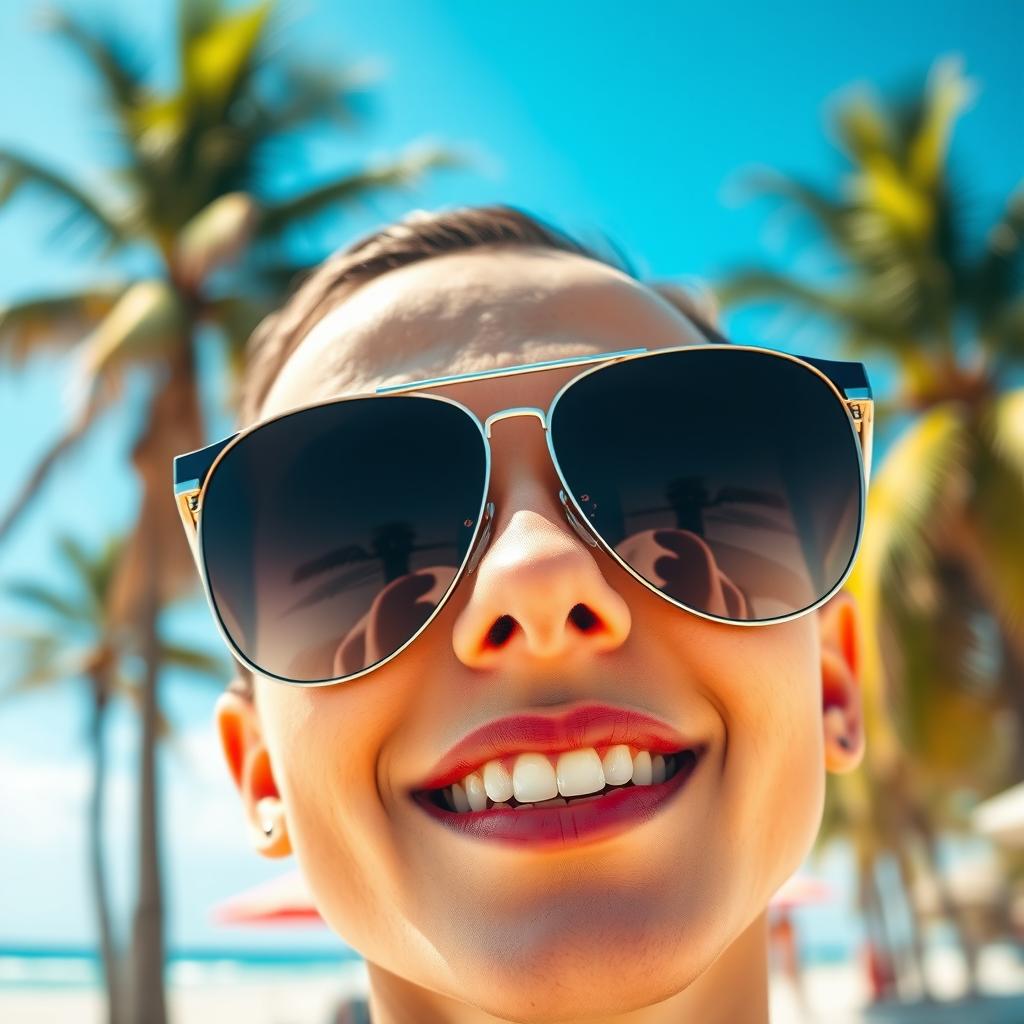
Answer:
0 536 229 1024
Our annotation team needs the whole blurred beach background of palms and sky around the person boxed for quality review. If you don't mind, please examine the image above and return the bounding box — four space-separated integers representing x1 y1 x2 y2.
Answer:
0 0 1024 1024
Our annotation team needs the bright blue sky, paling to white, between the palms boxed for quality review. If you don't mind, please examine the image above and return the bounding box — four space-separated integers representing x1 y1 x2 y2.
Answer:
0 0 1024 946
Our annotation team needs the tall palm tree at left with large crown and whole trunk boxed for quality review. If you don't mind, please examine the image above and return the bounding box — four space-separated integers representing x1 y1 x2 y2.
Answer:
0 0 463 1024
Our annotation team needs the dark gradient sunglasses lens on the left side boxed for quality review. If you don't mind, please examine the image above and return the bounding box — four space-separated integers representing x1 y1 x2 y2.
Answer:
200 395 486 682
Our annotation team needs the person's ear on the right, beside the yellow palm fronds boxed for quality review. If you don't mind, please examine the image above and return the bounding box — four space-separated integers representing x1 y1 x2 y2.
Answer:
818 590 864 773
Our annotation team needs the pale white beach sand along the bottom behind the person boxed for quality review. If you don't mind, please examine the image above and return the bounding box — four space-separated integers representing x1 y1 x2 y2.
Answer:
6 946 1024 1024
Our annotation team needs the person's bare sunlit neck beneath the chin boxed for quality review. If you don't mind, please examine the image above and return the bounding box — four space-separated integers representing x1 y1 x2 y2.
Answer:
367 911 769 1024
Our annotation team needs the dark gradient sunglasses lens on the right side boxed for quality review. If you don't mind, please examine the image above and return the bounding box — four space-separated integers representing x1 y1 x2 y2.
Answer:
551 347 863 622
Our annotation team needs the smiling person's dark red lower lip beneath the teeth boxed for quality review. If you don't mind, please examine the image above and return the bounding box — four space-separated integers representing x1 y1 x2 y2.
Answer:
413 749 706 849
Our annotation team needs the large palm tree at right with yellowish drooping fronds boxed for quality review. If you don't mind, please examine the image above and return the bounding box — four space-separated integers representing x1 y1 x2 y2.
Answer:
716 57 1024 999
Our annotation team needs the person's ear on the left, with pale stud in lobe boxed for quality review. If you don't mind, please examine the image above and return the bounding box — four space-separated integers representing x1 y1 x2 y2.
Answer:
214 690 292 857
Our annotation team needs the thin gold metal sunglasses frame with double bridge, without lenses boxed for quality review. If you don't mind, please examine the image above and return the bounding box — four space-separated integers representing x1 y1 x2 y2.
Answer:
173 344 874 686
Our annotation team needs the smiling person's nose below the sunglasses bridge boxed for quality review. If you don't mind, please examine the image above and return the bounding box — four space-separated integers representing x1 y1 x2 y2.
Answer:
452 424 632 669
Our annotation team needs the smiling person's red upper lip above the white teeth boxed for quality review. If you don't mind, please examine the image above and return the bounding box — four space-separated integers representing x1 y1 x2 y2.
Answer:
413 701 696 792
